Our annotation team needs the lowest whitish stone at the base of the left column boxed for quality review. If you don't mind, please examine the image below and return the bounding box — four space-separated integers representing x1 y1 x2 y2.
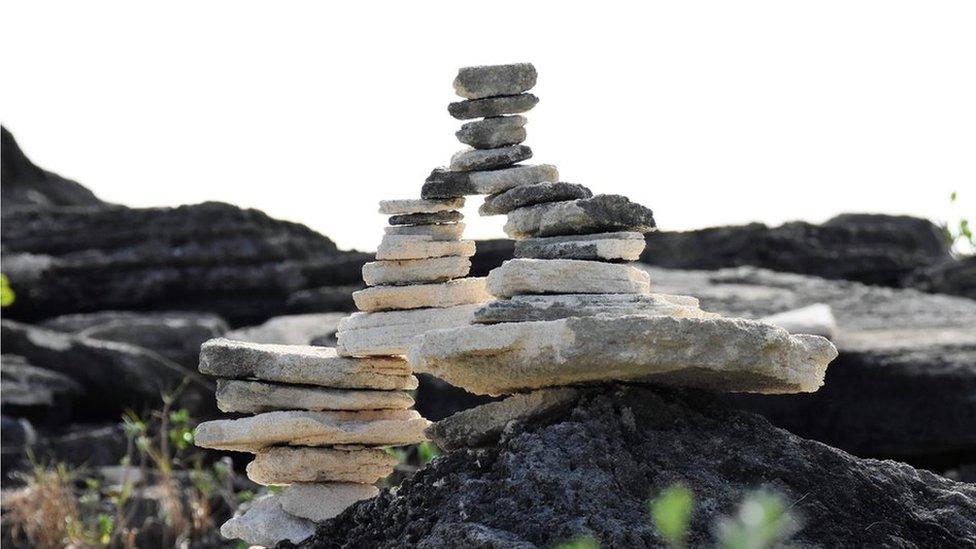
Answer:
220 495 315 547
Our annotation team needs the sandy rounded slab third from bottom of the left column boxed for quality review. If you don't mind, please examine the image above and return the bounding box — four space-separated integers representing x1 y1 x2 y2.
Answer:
247 447 397 486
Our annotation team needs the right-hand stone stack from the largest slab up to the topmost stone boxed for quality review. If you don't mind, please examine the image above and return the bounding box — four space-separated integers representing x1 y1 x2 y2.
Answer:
410 64 837 395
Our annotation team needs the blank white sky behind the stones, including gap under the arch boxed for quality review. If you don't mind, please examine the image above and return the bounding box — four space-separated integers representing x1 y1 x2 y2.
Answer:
0 0 976 249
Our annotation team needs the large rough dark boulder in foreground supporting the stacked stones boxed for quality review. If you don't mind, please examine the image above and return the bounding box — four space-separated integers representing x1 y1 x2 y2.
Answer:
281 386 976 548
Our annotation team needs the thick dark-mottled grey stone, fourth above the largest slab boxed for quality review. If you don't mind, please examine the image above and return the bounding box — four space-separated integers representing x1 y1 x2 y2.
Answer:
505 194 655 240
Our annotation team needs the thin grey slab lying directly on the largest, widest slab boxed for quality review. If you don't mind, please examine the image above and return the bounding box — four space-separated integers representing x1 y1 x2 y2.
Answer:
474 294 714 324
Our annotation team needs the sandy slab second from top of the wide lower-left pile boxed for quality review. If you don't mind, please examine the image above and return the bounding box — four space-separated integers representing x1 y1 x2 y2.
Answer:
217 379 413 413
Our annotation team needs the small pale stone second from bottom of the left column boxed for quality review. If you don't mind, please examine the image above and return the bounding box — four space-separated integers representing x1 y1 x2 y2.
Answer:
279 482 380 522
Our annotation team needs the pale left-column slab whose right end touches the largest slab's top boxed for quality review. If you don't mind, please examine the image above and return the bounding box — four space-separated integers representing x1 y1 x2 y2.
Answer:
336 304 481 356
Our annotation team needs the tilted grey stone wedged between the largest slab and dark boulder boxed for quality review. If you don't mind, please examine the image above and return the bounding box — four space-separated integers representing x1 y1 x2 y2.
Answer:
427 387 578 452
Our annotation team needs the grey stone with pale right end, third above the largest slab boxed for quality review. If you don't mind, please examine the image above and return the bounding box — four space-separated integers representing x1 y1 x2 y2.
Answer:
515 232 646 261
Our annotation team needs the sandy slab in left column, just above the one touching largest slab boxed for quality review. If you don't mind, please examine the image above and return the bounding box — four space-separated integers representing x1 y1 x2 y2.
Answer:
352 277 494 311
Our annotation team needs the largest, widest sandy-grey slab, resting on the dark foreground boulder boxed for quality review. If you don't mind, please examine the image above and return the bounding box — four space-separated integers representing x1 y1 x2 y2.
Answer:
410 316 837 395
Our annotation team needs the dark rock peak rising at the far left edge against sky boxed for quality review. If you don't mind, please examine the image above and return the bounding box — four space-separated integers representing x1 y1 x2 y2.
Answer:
0 127 104 210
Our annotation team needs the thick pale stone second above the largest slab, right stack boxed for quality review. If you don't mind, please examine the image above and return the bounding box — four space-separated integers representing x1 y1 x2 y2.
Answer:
486 259 651 298
